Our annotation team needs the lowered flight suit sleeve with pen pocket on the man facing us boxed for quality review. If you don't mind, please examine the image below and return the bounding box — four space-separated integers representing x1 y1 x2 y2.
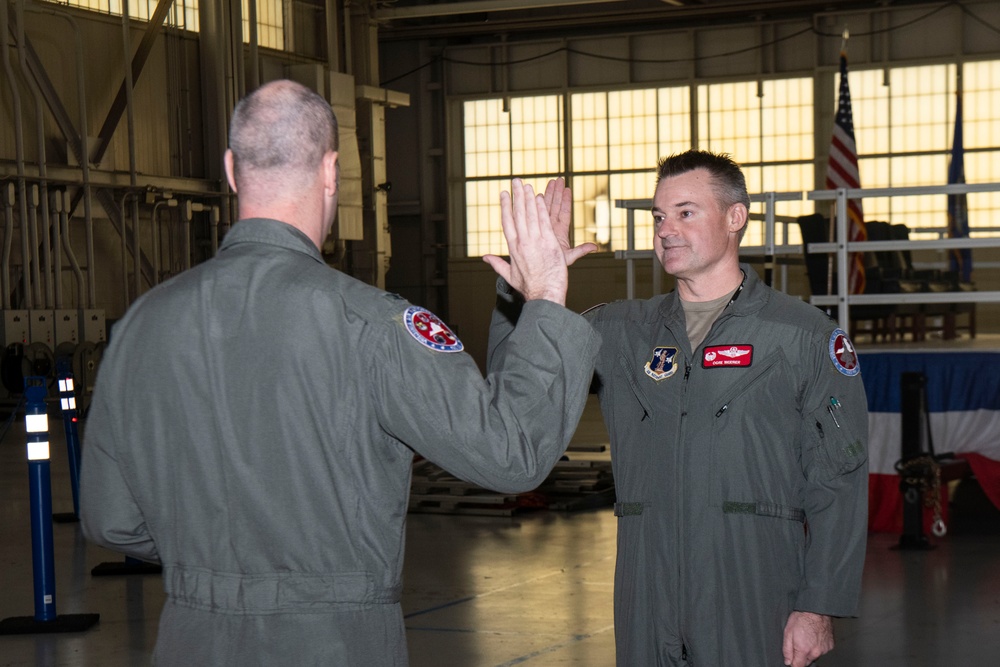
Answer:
795 330 868 616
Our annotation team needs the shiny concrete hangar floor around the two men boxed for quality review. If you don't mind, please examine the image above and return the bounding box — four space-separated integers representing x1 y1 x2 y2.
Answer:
0 396 1000 667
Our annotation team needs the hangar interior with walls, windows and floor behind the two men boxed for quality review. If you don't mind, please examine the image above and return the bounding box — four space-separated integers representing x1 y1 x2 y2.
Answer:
0 0 1000 665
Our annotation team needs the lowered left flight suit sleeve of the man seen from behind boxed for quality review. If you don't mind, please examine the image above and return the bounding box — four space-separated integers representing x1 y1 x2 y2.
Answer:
80 359 160 563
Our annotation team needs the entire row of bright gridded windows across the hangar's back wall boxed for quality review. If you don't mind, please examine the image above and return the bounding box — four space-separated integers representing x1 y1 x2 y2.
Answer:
465 61 1000 256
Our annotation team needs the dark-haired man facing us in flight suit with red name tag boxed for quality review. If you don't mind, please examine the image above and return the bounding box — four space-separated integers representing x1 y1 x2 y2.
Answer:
491 151 868 667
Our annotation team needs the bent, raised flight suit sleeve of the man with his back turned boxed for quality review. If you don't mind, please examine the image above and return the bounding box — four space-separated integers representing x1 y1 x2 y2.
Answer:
371 300 600 493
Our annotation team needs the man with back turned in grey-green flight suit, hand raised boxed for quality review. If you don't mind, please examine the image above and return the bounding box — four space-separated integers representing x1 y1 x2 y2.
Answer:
81 81 599 666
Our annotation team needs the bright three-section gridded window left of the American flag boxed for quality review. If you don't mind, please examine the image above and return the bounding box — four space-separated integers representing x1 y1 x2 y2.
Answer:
465 79 814 256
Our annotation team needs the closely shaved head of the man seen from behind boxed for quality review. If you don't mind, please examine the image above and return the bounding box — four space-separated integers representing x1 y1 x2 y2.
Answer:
229 80 338 195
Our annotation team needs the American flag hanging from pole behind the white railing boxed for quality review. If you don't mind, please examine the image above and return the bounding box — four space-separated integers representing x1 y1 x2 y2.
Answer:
826 51 868 294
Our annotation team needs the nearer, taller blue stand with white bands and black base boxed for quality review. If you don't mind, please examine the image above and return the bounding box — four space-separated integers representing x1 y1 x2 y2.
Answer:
0 377 100 635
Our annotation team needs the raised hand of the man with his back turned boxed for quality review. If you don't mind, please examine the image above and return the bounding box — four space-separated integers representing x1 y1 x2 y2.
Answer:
483 178 586 305
